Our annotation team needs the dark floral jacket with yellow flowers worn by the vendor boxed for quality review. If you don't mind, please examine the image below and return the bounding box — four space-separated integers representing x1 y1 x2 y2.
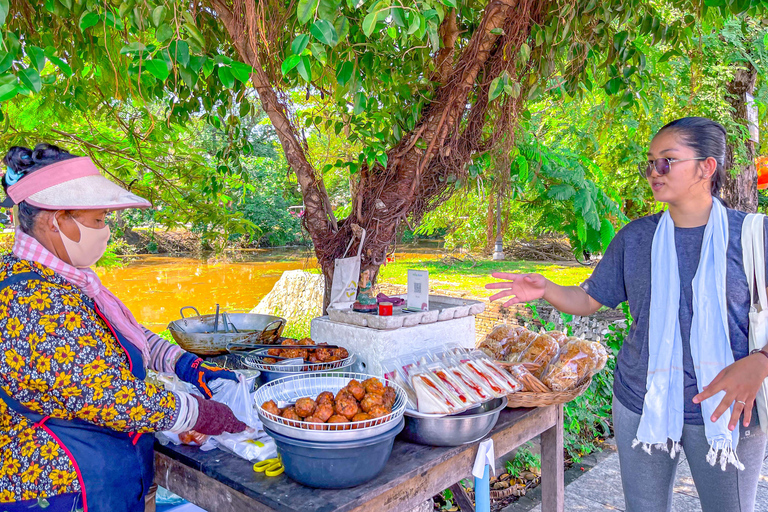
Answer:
0 255 177 502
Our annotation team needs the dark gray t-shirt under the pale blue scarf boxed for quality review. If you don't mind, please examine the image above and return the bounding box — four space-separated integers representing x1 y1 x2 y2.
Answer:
581 209 768 425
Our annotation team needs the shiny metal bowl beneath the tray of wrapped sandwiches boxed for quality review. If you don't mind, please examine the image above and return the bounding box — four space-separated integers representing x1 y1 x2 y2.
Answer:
400 397 507 446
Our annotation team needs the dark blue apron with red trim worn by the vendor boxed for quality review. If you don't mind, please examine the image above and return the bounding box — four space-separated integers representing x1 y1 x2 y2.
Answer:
0 272 154 512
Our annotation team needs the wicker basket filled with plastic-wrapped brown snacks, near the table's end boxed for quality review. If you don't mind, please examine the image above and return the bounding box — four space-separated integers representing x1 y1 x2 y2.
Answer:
478 324 608 407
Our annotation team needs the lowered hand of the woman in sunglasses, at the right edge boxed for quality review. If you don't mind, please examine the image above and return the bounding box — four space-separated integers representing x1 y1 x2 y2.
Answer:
693 354 768 430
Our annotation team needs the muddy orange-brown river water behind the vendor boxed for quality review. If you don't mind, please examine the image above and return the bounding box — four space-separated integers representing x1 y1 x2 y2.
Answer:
99 250 436 332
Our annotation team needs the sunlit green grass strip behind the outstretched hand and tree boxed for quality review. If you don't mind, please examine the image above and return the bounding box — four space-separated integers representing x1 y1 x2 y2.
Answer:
379 256 593 298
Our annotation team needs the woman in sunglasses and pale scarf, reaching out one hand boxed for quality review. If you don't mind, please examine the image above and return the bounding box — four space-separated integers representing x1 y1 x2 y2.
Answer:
487 117 768 512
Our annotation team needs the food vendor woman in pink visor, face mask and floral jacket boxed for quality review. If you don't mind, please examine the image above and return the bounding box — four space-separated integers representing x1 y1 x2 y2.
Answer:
0 144 245 512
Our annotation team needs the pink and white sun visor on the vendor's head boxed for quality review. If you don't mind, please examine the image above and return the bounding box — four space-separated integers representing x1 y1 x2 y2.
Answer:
0 156 152 210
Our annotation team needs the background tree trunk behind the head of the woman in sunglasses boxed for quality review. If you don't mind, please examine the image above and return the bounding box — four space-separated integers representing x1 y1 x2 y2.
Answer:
722 63 757 213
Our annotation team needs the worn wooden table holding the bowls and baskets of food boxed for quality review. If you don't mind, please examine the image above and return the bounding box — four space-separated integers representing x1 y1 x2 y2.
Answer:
155 406 563 512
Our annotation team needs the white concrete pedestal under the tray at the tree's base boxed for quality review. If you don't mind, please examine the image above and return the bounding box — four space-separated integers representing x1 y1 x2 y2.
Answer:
311 315 475 375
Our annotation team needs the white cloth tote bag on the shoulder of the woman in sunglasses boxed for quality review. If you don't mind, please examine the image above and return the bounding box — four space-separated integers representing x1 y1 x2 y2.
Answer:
741 214 768 433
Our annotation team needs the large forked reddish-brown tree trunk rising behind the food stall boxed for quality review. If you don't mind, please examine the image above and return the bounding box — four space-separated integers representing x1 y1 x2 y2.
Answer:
209 0 549 306
